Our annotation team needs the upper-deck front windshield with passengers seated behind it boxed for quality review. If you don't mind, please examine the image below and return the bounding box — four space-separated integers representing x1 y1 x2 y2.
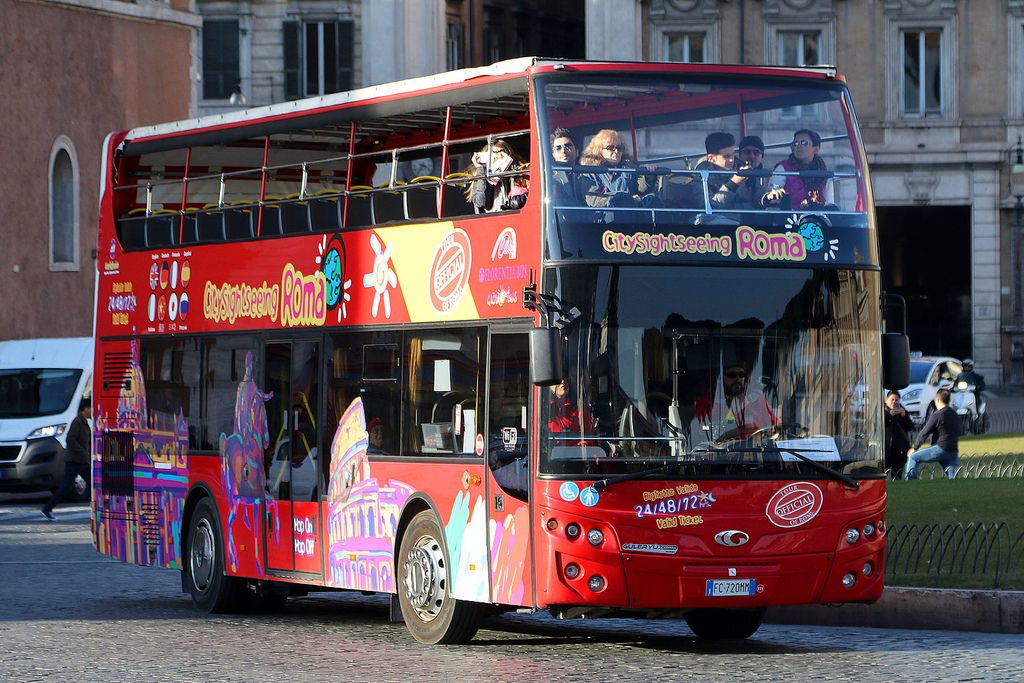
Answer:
539 74 867 227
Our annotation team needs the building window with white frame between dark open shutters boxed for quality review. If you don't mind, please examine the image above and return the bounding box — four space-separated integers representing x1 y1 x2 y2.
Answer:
285 22 353 99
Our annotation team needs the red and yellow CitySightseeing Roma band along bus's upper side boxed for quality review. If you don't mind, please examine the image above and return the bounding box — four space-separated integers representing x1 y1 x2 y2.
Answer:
97 216 540 334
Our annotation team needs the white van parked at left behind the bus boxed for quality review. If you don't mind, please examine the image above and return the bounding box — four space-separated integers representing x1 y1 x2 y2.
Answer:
0 337 93 500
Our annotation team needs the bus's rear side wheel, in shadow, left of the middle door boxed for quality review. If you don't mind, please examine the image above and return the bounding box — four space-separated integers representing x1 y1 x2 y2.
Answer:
182 499 251 614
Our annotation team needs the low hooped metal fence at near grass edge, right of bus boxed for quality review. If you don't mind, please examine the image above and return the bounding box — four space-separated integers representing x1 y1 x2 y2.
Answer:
886 522 1024 589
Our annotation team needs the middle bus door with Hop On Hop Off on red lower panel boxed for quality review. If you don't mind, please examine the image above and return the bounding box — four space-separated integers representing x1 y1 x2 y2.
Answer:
264 340 322 573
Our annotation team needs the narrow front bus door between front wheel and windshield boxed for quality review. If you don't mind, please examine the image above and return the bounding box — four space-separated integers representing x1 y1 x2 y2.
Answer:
486 333 534 605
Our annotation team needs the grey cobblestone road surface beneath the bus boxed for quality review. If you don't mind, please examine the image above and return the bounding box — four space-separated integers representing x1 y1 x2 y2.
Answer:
0 501 1024 683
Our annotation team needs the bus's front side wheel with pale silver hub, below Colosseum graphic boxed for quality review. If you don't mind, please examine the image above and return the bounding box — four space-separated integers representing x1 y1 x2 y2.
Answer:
396 510 486 645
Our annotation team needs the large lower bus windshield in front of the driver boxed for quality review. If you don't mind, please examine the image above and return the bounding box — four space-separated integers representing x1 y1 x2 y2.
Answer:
541 265 883 478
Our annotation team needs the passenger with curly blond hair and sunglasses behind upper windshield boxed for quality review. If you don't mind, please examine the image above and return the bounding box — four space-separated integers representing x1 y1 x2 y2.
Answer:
580 128 662 208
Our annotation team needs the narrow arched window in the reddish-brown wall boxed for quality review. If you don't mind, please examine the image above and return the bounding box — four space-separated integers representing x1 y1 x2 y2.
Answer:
49 135 79 270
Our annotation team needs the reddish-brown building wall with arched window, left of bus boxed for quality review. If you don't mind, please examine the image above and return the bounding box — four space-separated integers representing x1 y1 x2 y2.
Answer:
0 0 200 339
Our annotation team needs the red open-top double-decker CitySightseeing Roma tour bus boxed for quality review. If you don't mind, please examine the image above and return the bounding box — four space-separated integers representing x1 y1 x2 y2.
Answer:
93 58 898 643
